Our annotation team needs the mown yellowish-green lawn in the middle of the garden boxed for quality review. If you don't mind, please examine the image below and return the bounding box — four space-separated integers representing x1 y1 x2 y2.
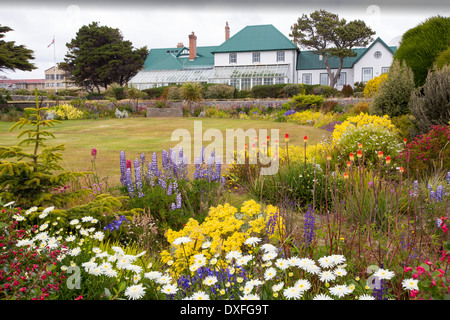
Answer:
0 118 330 186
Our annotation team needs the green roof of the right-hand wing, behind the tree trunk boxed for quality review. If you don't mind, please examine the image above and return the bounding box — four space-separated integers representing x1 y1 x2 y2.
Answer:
297 38 397 70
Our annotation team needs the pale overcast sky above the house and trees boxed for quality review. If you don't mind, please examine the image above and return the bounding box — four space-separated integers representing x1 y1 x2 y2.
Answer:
0 0 450 79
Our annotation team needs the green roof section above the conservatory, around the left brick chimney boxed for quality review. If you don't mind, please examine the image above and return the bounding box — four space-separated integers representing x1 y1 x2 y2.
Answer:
144 46 216 70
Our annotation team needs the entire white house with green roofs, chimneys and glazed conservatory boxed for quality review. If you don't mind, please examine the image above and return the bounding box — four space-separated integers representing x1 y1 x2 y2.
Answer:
130 23 395 90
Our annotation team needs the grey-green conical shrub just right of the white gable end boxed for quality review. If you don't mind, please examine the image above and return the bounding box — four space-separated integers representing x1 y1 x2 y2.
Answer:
370 60 414 117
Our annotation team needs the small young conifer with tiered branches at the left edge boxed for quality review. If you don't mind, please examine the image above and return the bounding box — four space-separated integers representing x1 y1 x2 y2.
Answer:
0 89 88 207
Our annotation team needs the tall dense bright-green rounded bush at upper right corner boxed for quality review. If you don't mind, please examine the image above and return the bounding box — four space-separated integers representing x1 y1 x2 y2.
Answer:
394 16 450 87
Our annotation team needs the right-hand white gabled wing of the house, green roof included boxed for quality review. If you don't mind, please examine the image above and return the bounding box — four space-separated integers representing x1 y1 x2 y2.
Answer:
297 38 396 89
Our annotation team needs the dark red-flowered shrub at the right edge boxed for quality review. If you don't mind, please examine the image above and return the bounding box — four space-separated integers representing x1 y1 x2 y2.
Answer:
399 125 450 174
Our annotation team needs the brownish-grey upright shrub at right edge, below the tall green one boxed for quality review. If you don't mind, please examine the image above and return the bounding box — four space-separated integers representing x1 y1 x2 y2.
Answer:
411 65 450 133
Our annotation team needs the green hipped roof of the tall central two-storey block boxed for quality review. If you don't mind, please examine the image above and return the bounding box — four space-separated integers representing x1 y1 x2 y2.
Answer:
213 24 298 53
